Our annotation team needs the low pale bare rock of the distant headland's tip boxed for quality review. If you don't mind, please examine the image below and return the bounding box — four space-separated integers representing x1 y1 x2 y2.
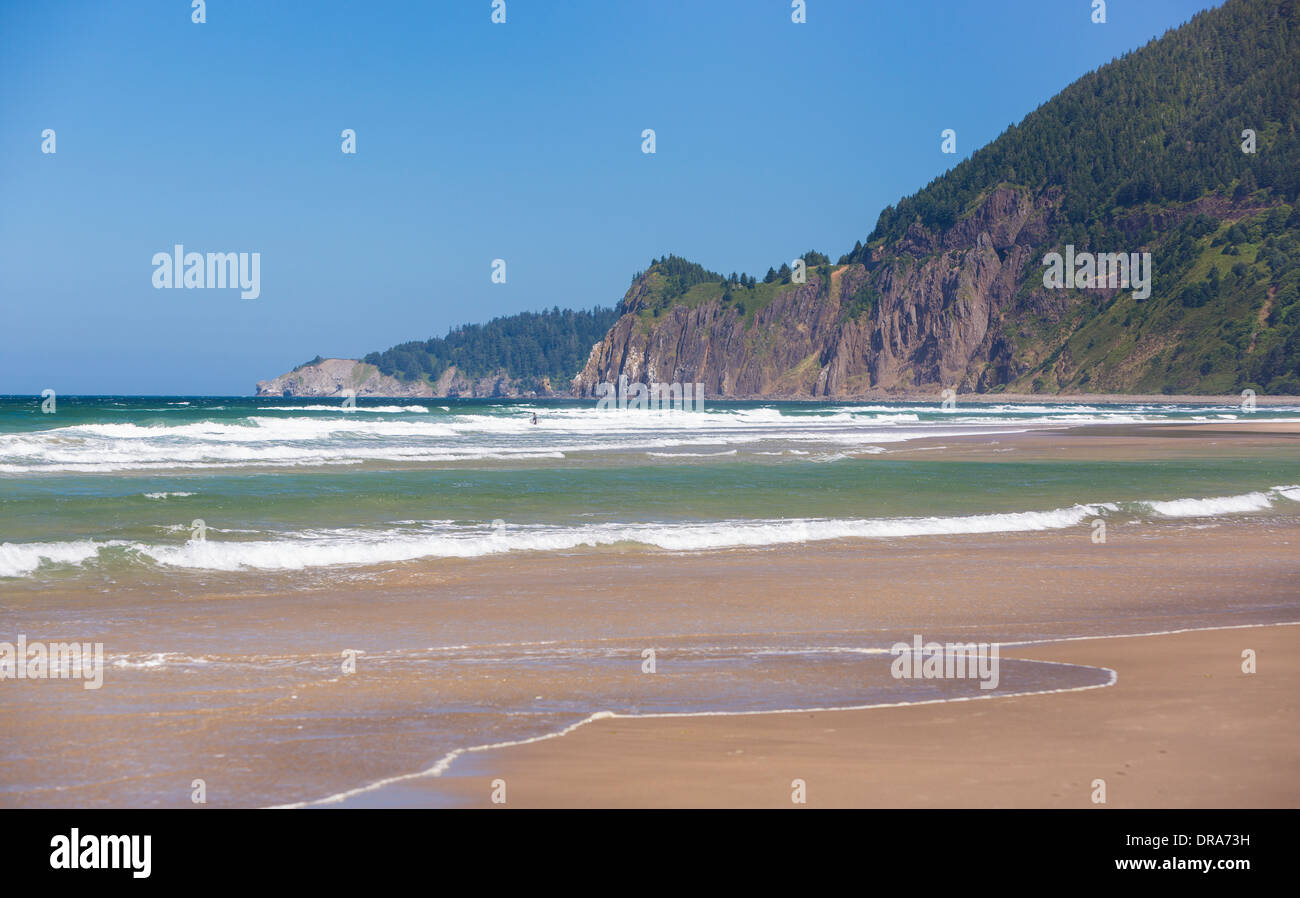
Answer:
256 359 568 399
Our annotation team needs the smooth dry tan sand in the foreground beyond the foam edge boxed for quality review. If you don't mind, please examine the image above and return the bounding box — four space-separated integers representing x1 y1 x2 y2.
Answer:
426 626 1300 808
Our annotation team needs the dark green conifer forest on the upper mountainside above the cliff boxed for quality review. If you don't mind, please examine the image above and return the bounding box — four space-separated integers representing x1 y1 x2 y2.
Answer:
850 0 1300 253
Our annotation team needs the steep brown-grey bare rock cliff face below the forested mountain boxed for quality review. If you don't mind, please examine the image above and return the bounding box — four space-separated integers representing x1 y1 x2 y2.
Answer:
573 188 1070 398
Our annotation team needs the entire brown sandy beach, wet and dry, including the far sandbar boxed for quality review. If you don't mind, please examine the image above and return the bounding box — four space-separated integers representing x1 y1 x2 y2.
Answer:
0 421 1300 807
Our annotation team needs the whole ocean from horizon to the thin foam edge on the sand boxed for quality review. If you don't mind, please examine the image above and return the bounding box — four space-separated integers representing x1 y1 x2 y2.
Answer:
0 396 1300 806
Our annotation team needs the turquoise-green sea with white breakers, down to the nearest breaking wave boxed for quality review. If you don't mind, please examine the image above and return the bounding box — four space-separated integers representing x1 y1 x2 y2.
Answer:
0 396 1300 587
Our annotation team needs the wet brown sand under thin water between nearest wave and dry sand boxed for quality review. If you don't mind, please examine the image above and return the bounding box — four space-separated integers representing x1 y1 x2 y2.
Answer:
0 520 1300 807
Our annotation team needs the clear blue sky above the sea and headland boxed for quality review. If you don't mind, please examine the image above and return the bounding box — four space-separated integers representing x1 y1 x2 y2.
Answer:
0 0 1216 395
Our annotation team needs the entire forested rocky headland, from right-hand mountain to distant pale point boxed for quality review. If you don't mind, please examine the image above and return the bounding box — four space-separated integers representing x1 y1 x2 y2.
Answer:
259 0 1300 398
